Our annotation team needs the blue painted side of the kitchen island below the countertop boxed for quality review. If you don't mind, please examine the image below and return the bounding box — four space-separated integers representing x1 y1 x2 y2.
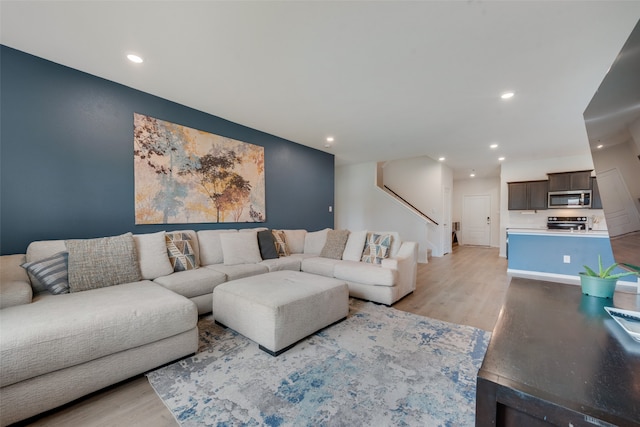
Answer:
508 233 637 282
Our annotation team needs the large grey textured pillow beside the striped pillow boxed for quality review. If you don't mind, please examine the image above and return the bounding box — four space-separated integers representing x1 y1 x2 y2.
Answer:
65 233 142 292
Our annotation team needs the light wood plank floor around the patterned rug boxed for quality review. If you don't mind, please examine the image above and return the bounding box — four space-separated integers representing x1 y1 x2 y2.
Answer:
21 246 509 427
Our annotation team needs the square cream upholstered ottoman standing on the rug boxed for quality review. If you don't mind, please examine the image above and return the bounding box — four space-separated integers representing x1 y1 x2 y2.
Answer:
213 271 349 356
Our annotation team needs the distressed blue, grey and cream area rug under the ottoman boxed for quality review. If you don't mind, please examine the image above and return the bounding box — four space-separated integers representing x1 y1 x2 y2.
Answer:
147 299 490 426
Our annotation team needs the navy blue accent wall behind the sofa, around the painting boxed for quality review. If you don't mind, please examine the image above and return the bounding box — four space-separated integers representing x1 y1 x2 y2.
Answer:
0 46 334 255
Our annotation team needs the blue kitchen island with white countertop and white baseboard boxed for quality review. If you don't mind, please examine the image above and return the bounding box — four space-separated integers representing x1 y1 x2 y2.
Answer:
507 228 638 292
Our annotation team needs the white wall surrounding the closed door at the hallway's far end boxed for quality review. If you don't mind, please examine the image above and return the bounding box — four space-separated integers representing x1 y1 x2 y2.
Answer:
452 177 501 247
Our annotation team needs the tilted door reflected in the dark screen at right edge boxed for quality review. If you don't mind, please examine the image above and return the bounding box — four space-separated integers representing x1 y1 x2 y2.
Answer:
597 168 640 237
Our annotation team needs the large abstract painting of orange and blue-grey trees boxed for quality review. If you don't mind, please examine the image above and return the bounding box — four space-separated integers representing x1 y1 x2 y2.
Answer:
133 113 266 224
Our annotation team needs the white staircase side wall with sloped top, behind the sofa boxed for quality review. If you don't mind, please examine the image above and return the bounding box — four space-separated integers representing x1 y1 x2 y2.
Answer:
334 163 430 262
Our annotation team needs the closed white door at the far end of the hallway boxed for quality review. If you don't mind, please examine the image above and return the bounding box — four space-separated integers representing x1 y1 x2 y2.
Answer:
460 195 491 246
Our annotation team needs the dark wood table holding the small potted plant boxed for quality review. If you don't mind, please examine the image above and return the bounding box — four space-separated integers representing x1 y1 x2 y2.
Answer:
476 278 640 427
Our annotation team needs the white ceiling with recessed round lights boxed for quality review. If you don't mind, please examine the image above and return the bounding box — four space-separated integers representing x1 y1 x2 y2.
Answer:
0 0 640 179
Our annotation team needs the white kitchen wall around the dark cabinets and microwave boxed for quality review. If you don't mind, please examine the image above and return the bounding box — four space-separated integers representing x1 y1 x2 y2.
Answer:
499 154 604 256
